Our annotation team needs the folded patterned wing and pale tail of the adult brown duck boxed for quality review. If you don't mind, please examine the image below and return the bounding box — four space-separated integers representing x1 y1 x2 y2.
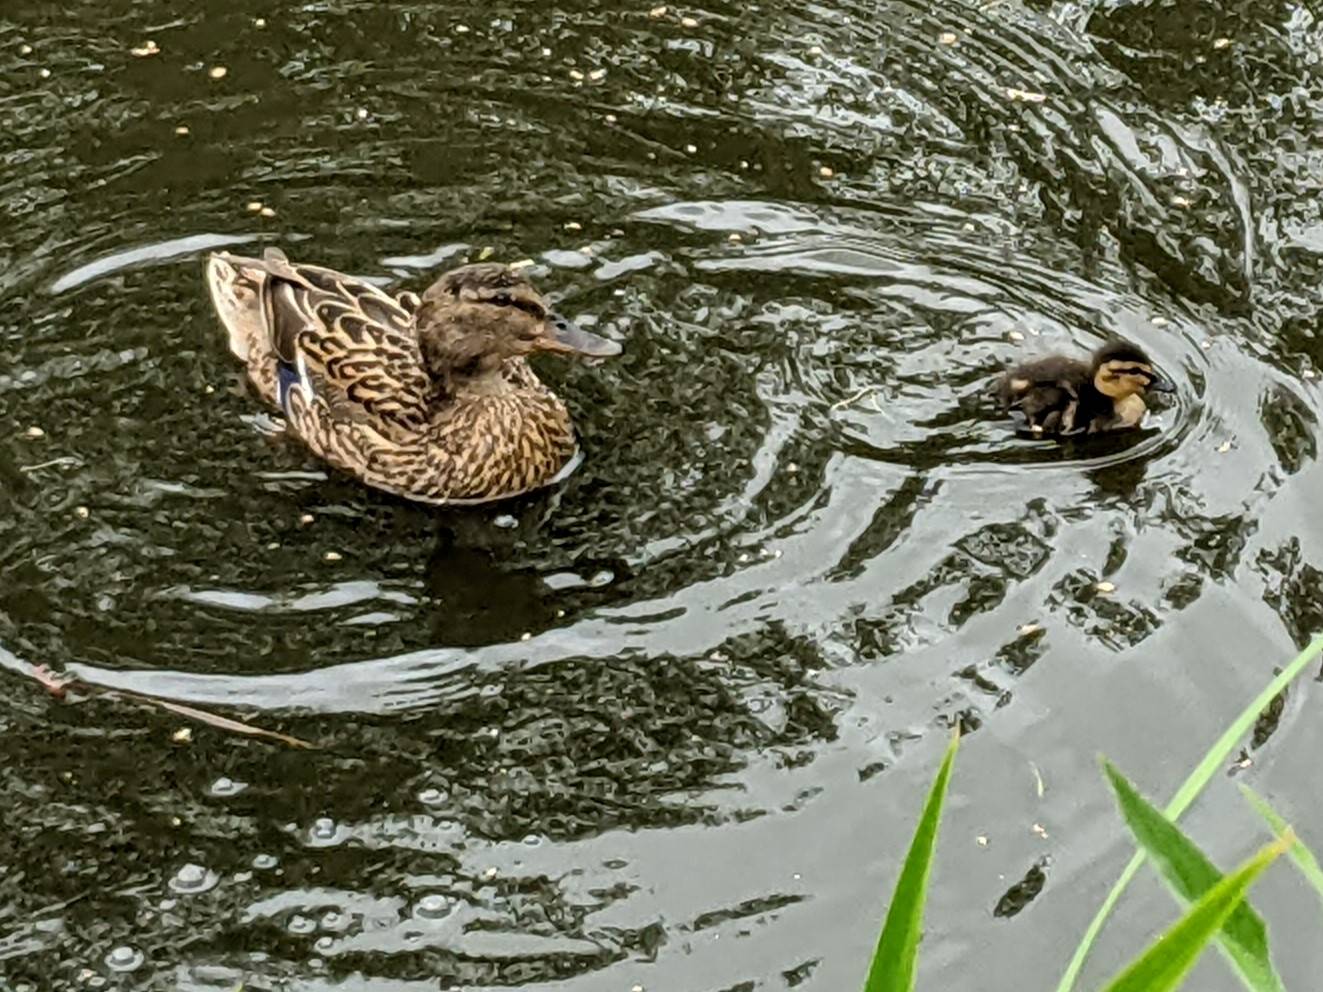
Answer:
208 249 433 438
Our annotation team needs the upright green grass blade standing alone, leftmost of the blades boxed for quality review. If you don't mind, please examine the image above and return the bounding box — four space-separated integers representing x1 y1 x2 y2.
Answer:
864 734 960 992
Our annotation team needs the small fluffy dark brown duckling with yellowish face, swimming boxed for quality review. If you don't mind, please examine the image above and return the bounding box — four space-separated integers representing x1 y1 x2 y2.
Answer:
998 341 1176 435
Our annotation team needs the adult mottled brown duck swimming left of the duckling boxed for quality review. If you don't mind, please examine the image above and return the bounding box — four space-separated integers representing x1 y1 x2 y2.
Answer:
206 249 620 504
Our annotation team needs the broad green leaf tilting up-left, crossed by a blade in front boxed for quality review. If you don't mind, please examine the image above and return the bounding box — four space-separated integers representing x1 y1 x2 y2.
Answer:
1102 759 1286 992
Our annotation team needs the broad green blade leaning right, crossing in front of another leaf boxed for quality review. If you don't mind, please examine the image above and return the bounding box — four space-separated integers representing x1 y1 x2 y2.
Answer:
1105 835 1294 992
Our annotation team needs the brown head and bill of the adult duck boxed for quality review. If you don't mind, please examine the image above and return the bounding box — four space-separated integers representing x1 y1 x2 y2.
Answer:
415 263 620 377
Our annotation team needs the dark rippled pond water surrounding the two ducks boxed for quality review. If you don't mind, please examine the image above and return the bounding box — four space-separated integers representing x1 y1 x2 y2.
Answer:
0 0 1323 992
